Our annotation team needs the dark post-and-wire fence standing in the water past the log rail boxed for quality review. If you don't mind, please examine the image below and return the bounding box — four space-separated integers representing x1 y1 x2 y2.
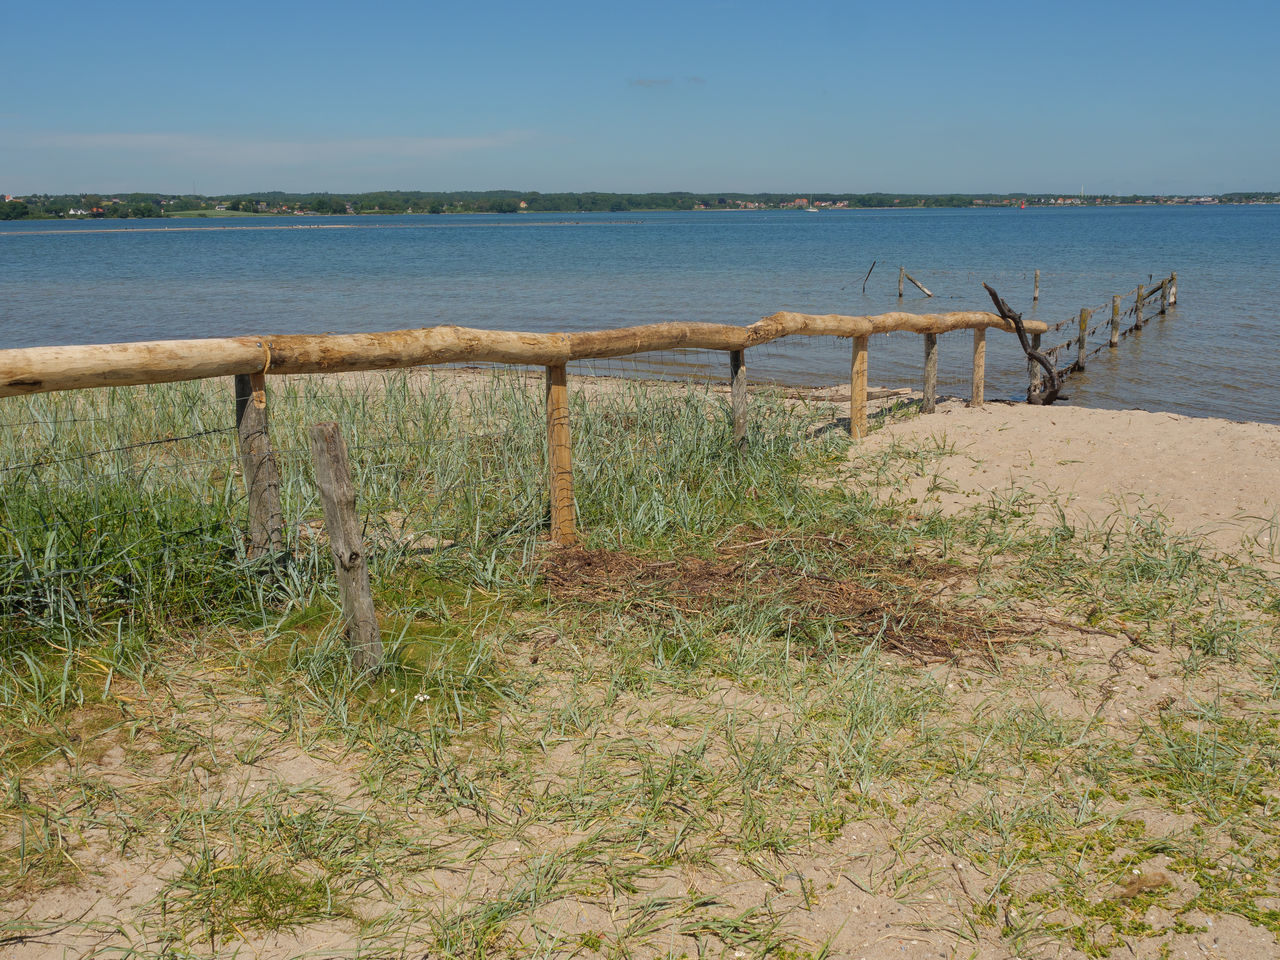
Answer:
1027 270 1178 393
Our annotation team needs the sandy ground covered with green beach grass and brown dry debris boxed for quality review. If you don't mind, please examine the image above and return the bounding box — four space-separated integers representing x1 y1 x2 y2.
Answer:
0 370 1280 957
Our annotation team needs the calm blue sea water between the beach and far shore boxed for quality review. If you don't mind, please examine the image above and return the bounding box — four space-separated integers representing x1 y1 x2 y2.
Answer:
0 206 1280 422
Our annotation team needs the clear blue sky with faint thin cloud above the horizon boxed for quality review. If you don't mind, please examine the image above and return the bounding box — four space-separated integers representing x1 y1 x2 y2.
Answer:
0 0 1280 195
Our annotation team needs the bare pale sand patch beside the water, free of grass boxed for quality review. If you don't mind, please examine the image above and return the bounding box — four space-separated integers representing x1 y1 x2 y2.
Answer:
851 401 1280 562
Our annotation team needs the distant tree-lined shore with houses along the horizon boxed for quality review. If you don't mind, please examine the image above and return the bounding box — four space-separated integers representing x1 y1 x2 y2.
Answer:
0 189 1280 220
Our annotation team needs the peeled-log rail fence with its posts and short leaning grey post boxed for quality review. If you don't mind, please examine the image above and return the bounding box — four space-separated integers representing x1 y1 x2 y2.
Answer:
0 311 1047 667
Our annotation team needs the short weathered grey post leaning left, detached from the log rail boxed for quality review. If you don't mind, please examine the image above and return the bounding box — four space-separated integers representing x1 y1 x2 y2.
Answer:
310 421 383 671
